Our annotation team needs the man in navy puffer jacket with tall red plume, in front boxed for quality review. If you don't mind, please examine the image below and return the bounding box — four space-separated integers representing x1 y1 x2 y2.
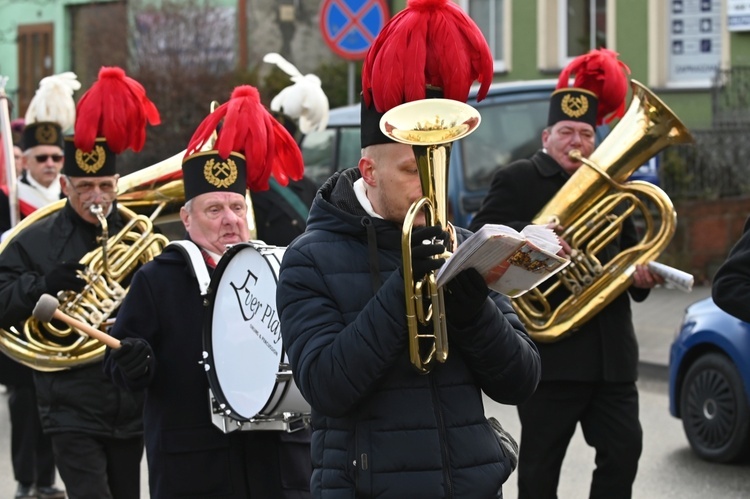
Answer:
276 0 539 499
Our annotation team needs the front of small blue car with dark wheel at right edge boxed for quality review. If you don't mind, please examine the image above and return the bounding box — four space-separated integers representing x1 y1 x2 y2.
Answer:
669 298 750 463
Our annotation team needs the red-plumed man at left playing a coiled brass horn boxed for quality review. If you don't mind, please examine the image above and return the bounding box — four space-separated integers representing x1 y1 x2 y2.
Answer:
0 67 159 499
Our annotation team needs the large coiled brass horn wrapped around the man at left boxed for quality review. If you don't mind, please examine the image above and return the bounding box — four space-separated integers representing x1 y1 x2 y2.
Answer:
0 151 184 371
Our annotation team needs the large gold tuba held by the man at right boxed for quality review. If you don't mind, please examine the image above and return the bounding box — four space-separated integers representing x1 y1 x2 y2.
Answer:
513 80 693 342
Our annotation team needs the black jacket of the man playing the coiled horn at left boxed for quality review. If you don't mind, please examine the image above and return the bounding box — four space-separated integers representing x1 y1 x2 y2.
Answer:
0 204 143 438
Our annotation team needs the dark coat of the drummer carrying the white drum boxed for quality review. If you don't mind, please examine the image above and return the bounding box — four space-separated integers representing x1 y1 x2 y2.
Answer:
105 246 310 499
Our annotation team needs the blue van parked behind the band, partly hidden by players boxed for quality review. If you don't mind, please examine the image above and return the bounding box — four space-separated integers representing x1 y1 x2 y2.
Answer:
301 80 657 227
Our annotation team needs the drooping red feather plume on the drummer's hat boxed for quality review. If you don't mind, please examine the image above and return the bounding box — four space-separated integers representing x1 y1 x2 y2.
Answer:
185 85 304 191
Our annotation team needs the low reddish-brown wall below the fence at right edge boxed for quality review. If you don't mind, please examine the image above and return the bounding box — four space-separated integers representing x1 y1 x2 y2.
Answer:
659 198 750 284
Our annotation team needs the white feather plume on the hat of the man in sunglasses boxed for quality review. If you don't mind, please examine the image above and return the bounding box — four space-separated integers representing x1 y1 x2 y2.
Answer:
26 71 81 131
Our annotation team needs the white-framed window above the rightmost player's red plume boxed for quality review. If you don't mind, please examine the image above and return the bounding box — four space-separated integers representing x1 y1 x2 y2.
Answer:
558 0 607 67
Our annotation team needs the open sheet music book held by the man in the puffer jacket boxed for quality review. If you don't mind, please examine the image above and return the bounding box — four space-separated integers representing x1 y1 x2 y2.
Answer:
437 224 570 298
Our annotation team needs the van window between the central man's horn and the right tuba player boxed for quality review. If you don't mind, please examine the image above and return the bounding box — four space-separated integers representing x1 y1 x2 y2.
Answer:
461 99 549 191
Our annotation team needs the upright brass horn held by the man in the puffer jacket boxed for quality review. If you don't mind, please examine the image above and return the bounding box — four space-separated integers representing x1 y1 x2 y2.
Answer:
380 99 481 373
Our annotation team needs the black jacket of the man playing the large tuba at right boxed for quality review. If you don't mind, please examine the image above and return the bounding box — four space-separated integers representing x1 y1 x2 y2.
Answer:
470 151 649 382
